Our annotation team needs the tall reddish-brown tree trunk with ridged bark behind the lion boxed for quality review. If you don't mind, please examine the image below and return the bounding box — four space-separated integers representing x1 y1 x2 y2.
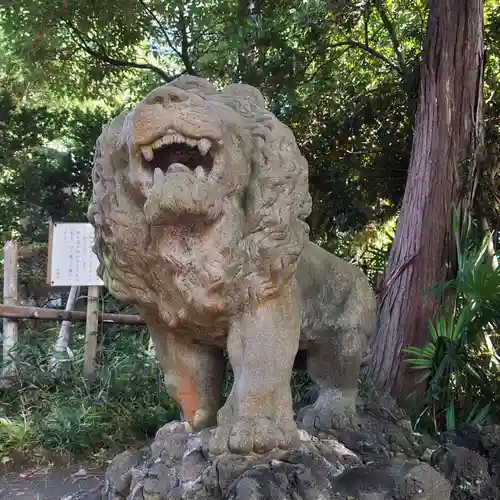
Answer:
368 0 484 397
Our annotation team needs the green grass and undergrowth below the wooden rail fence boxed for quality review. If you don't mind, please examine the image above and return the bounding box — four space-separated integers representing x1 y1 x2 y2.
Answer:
0 323 178 458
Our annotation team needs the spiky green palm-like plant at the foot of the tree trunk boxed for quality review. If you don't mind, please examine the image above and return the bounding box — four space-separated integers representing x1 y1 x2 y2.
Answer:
405 209 500 431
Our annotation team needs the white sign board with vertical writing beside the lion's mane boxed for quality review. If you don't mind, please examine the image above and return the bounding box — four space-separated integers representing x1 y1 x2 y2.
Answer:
48 222 104 286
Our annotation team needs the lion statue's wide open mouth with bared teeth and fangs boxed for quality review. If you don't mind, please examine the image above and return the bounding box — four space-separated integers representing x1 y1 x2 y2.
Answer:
141 132 214 178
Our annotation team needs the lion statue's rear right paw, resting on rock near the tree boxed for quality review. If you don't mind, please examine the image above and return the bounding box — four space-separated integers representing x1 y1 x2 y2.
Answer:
298 404 356 432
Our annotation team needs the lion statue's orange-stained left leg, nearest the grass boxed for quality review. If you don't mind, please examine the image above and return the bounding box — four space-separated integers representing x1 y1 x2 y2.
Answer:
151 330 225 430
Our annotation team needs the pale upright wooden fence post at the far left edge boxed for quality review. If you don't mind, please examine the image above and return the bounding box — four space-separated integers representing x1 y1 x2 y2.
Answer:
2 241 19 385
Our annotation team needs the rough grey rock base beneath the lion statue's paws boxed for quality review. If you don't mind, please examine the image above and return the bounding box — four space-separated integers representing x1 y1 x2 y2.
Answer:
64 399 500 500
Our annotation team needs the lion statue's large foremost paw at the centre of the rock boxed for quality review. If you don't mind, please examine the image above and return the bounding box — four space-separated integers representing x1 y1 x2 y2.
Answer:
210 418 299 455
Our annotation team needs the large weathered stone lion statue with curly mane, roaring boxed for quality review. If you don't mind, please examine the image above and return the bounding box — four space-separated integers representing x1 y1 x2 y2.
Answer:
88 77 375 453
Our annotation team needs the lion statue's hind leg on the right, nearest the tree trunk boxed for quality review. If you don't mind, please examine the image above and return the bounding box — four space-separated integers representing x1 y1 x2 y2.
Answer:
299 329 363 431
